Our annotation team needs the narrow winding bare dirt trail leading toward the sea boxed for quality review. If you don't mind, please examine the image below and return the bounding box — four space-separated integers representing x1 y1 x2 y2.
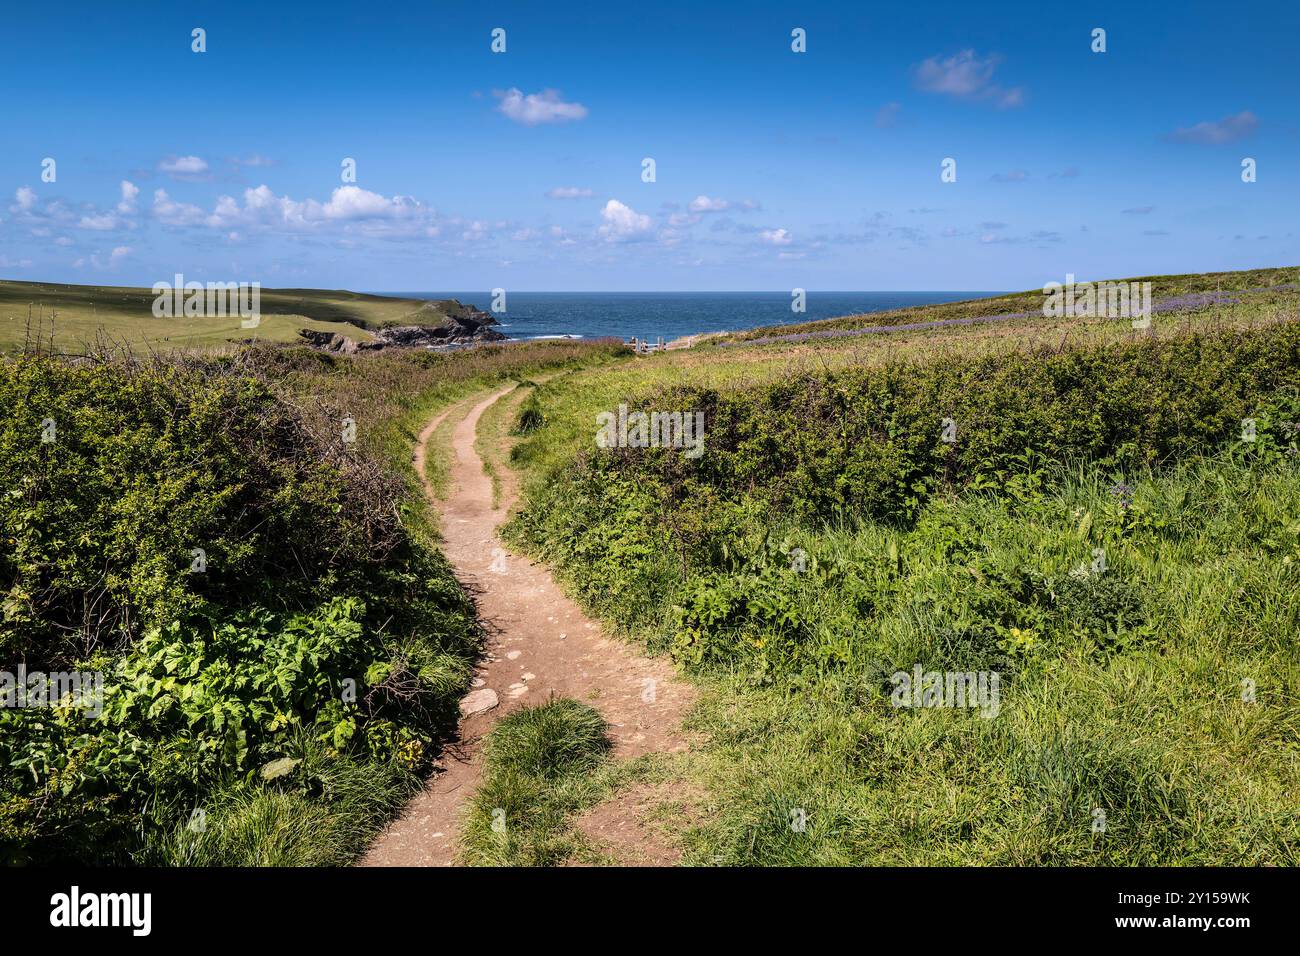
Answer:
361 386 694 866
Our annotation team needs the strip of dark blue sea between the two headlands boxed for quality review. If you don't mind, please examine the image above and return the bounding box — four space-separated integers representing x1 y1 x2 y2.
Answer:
382 291 1002 342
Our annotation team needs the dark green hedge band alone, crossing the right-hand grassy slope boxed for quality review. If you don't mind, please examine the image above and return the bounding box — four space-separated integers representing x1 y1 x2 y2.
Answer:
598 324 1300 520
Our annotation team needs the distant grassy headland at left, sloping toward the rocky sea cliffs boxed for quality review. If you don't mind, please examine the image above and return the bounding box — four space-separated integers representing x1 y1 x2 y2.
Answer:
0 281 491 354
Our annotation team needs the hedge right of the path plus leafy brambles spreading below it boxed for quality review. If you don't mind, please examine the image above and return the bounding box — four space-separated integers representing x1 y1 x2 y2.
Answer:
511 324 1300 672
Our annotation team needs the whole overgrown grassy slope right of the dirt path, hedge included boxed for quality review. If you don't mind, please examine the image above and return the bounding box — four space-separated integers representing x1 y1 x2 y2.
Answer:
485 269 1300 865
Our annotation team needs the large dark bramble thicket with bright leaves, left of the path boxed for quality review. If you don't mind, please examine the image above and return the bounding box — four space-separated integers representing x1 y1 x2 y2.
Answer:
0 356 478 862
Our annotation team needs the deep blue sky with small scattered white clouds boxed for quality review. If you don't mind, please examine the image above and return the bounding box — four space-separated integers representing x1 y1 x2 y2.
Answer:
0 1 1300 291
